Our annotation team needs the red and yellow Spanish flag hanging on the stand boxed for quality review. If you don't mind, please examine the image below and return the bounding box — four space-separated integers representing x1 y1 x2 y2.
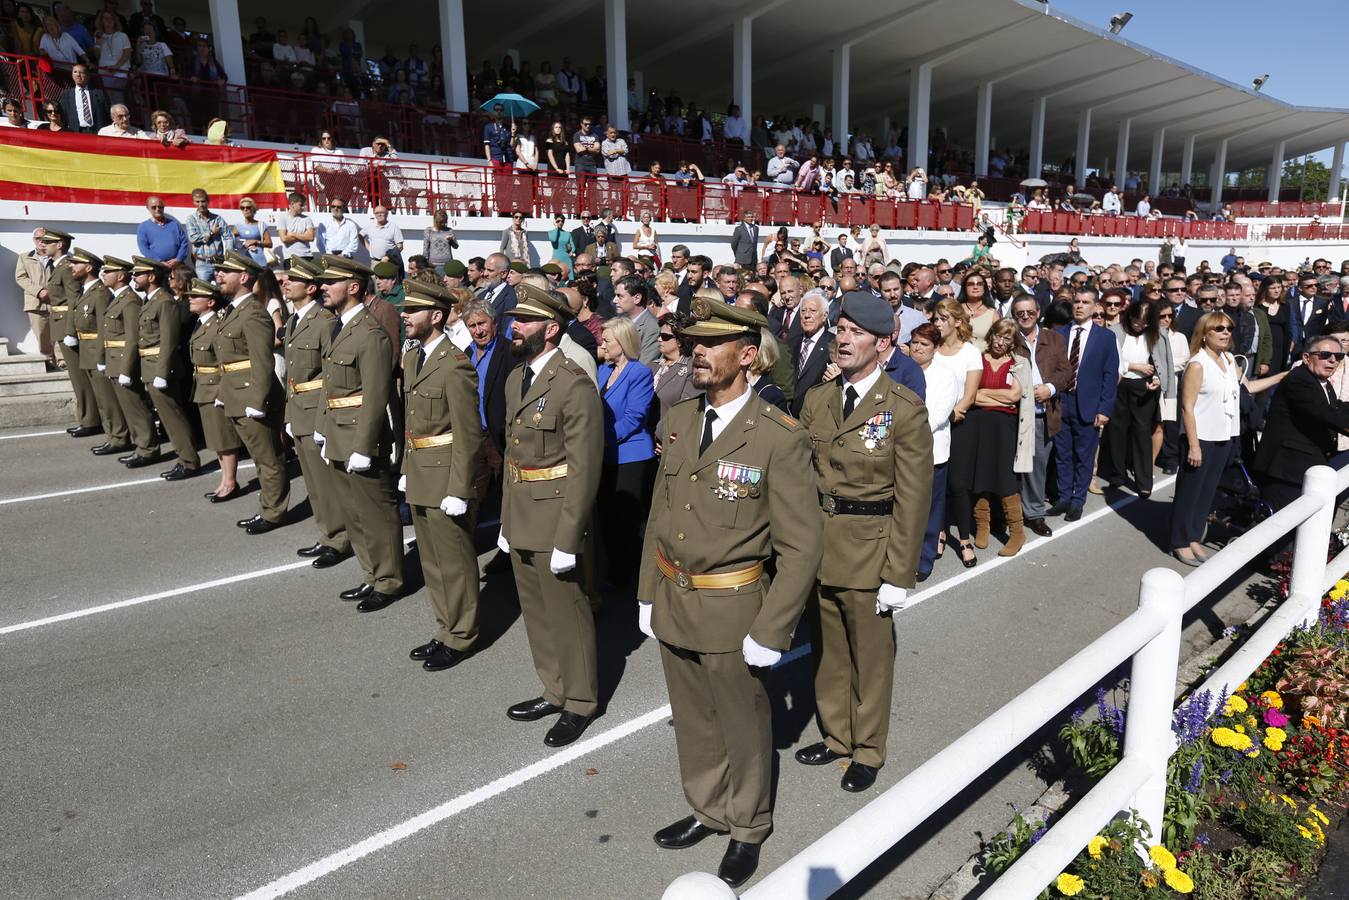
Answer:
0 128 286 209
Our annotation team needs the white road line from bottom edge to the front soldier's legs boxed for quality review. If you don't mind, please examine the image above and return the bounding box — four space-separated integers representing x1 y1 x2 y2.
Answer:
239 704 670 900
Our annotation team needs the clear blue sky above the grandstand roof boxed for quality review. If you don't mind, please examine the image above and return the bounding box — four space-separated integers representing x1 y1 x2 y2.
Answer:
1050 0 1349 165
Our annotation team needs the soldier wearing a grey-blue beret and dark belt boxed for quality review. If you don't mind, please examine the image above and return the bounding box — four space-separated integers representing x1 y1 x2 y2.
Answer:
796 291 932 792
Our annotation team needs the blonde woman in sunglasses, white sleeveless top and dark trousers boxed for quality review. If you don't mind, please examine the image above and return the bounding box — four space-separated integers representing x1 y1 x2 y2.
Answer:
1171 312 1289 565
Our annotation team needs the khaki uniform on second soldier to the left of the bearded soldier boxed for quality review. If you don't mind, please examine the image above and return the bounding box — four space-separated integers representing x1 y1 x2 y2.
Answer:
313 308 403 596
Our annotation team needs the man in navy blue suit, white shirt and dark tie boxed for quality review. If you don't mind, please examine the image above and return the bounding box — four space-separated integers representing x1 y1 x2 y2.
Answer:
1045 287 1120 522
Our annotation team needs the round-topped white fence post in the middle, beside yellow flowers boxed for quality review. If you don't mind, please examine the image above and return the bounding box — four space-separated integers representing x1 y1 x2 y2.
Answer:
1124 568 1184 843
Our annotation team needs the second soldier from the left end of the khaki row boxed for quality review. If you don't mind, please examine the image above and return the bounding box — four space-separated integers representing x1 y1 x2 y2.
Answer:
66 247 131 456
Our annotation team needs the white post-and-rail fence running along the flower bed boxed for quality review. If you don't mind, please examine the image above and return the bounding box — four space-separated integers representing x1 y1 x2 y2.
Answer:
664 466 1349 900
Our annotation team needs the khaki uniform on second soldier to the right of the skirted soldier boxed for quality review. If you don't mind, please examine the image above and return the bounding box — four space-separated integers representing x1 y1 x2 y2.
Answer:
285 300 351 556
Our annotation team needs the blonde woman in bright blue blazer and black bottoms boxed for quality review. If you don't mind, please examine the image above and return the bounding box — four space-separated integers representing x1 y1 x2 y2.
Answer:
595 316 656 587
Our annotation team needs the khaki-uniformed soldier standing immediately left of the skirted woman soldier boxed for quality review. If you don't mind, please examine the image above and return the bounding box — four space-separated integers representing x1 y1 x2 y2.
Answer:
128 256 201 482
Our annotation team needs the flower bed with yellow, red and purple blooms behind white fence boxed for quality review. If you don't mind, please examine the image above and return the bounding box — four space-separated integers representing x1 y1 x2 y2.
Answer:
983 582 1349 900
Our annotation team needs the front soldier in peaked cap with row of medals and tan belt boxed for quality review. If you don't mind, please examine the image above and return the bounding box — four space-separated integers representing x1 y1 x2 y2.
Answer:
637 297 823 887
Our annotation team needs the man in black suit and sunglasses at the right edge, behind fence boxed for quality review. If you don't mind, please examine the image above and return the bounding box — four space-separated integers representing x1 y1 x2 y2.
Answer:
1253 335 1349 510
